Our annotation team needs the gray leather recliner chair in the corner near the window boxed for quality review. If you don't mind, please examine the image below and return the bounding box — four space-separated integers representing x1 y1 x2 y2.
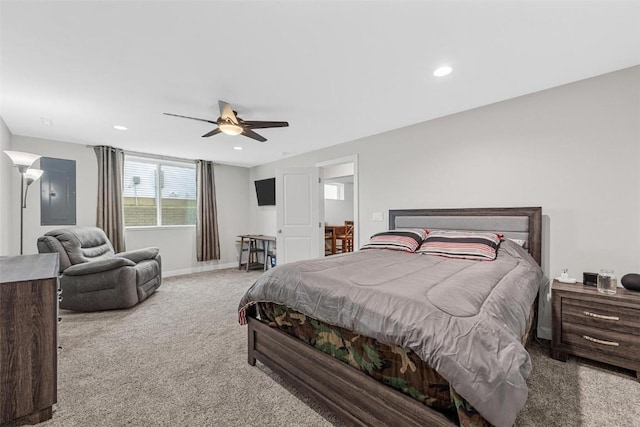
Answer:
38 227 162 311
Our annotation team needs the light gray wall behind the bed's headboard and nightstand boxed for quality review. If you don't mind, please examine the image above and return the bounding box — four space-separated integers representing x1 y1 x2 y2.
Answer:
250 66 640 338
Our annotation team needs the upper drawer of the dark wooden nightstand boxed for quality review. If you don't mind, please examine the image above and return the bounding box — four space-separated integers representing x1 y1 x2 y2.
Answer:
562 298 640 336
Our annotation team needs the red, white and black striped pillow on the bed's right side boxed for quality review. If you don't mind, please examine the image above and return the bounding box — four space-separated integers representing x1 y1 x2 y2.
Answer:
416 230 502 261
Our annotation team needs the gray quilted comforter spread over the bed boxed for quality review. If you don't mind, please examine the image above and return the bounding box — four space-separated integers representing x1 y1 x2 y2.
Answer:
240 240 542 426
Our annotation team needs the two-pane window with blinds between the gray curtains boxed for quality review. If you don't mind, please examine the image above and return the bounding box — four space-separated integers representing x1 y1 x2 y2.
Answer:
123 156 196 227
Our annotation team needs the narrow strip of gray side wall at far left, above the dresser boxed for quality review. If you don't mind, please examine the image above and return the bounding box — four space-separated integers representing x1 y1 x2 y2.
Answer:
0 117 13 256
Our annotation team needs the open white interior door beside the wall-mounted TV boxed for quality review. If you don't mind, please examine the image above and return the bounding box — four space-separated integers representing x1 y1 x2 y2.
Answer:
276 167 324 264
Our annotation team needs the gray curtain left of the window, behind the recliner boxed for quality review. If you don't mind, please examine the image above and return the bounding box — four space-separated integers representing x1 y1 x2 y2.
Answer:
93 145 125 252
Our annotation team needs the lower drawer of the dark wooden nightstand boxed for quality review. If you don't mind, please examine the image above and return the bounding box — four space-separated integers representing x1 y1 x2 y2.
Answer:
561 322 640 362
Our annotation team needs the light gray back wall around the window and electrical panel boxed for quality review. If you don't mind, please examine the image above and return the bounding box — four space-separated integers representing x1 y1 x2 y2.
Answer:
9 135 249 275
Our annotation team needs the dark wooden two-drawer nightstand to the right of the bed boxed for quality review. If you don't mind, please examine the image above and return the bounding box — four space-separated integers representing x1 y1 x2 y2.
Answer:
551 281 640 379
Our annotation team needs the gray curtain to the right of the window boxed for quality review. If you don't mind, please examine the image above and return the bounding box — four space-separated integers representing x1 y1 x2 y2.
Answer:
196 160 220 261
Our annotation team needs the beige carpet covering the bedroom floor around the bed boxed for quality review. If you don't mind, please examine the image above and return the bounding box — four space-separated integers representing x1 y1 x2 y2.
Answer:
26 270 640 427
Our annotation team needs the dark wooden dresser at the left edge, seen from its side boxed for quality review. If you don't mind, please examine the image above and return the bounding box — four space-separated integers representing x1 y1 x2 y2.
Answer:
0 254 58 424
